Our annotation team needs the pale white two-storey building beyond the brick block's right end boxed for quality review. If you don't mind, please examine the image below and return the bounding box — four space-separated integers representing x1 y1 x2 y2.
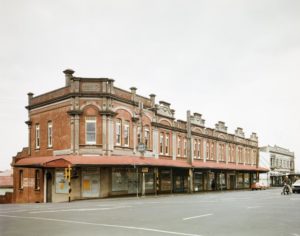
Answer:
259 145 295 186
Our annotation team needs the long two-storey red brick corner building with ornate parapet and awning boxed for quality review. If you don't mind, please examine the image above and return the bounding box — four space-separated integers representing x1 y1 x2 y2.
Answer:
12 69 267 202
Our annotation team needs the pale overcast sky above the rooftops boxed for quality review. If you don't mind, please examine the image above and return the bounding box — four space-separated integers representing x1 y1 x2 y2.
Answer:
0 0 300 170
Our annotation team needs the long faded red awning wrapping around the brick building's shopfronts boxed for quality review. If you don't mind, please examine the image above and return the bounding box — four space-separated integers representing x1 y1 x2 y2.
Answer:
14 155 269 172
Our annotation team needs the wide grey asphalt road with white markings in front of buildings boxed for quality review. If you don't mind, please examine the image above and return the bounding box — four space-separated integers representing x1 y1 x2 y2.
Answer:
0 188 300 236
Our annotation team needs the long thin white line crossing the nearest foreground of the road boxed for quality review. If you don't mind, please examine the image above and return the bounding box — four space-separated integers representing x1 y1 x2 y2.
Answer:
0 215 201 236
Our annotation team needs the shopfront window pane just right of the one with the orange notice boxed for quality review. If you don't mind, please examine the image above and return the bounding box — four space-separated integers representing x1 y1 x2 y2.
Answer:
112 168 128 192
